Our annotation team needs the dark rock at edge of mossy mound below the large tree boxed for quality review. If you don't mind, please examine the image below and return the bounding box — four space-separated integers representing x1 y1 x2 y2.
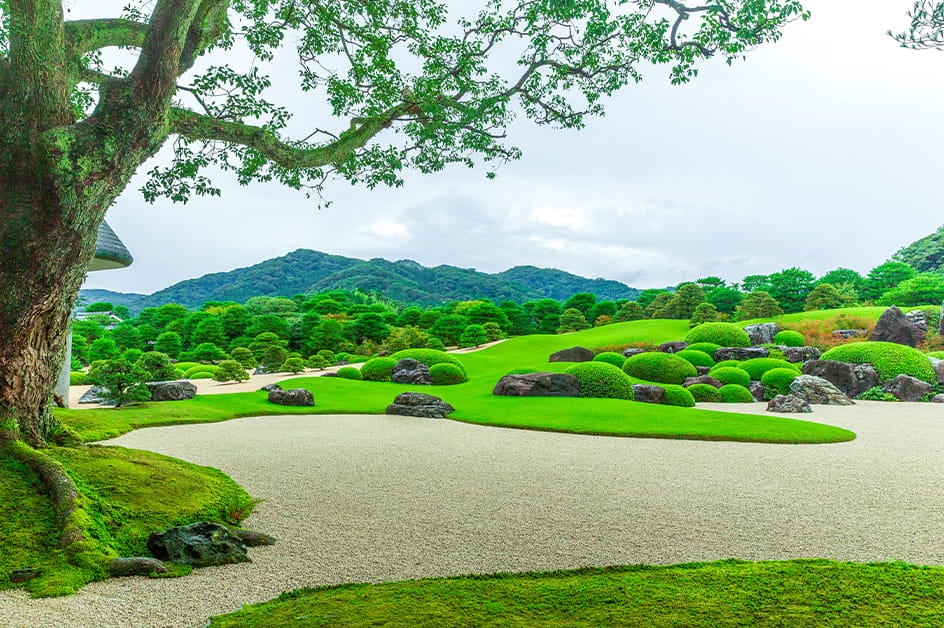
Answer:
148 521 249 567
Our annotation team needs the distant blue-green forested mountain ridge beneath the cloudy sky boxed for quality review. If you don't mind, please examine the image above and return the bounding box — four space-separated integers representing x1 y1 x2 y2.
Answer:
80 249 639 312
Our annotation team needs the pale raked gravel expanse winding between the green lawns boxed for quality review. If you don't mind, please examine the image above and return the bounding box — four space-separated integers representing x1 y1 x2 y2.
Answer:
0 402 944 628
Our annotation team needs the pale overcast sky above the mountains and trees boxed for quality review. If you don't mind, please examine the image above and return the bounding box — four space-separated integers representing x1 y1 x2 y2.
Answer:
79 0 944 296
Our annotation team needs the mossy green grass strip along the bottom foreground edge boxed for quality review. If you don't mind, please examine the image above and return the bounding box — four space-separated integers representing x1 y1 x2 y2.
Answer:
210 560 944 628
